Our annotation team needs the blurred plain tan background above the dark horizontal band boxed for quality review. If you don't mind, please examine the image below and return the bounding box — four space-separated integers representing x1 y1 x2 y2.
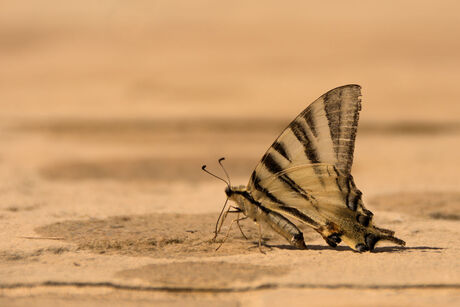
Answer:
0 0 460 122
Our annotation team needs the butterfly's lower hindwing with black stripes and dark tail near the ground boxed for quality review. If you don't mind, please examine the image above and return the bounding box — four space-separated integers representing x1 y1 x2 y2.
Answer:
251 163 405 251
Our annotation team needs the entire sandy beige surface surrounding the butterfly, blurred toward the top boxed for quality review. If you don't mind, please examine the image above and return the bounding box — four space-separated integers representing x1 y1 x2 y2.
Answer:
0 1 460 306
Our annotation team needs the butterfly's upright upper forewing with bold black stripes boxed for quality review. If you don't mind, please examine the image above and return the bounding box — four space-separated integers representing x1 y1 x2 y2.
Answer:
249 85 361 188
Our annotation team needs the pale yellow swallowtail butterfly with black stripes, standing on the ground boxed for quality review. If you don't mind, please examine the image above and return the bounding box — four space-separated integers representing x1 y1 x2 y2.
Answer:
202 84 405 252
